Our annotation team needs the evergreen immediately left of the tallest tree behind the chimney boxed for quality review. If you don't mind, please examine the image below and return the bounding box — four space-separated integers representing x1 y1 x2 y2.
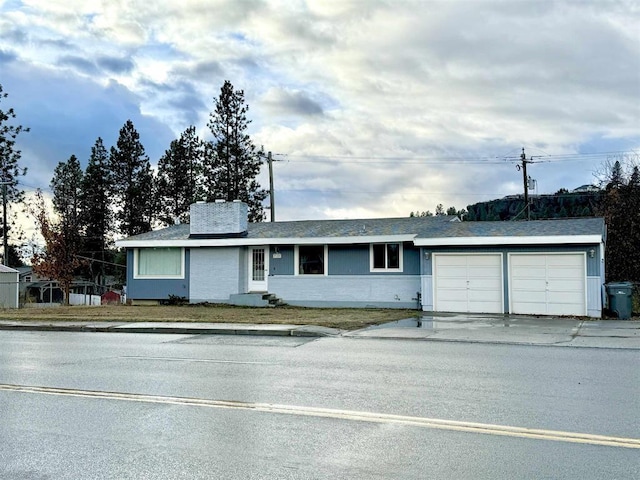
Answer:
155 125 204 225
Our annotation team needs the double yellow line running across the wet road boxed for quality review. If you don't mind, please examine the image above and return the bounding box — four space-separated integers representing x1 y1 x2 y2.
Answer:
0 384 640 449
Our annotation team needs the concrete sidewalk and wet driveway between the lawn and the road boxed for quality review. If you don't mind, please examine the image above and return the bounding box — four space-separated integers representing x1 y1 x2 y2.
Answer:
0 314 640 349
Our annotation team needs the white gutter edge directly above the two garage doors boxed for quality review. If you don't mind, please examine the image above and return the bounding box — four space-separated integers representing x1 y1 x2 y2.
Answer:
413 235 602 247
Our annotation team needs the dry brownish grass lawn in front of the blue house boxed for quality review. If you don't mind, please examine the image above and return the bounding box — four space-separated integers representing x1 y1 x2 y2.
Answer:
0 305 417 330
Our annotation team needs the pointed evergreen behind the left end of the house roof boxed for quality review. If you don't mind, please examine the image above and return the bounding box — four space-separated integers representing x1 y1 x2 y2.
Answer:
109 120 154 236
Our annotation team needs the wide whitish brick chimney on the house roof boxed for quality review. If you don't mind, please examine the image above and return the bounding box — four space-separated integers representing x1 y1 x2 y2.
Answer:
189 200 249 238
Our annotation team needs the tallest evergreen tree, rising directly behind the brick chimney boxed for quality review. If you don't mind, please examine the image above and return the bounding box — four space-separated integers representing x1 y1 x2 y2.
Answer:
205 80 267 222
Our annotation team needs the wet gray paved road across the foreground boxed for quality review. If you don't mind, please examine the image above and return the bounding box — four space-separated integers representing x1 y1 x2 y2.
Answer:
0 331 640 479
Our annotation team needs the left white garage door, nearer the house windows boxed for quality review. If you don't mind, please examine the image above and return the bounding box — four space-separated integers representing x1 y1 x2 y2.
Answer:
433 253 503 313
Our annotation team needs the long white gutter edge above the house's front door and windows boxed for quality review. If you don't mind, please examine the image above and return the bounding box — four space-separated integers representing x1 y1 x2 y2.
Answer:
116 234 415 248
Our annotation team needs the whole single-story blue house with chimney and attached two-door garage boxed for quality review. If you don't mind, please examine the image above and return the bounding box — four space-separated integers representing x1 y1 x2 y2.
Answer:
116 202 605 317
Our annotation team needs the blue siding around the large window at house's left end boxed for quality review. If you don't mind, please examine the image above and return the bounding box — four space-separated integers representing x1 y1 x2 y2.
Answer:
127 248 190 300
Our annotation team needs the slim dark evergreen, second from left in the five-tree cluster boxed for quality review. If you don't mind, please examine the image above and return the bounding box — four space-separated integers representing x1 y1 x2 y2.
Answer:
81 137 113 283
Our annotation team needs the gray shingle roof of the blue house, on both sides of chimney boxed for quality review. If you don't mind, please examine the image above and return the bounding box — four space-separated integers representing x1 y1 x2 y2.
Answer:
120 216 605 242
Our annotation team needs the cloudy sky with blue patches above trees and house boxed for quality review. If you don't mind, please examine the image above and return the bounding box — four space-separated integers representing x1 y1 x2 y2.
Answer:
0 0 640 220
